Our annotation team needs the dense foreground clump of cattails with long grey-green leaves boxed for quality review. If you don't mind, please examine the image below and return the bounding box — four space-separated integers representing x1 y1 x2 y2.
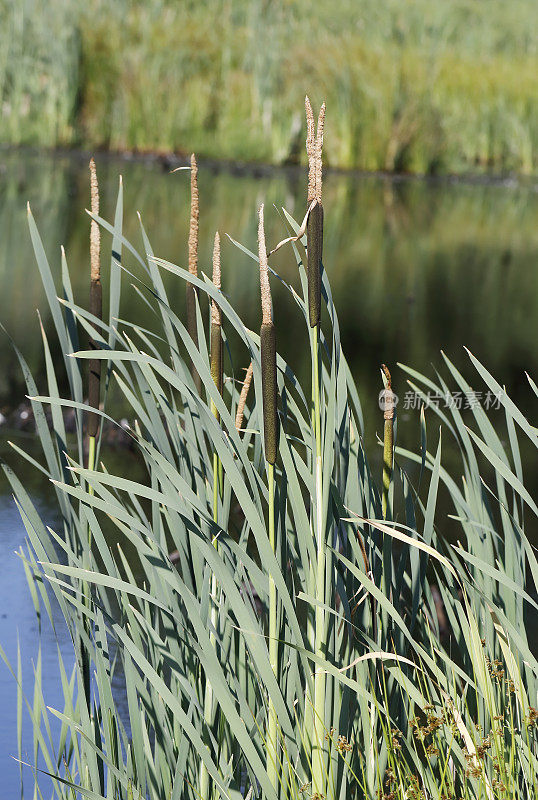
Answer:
4 107 538 800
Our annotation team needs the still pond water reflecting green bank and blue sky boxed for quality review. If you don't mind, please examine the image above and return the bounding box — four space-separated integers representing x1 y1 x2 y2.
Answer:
0 151 538 798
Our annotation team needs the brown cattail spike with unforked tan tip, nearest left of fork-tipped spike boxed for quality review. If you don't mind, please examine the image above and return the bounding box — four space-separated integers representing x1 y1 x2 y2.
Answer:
258 205 278 464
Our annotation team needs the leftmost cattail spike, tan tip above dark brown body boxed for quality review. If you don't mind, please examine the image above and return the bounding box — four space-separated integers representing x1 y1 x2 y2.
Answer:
88 158 103 437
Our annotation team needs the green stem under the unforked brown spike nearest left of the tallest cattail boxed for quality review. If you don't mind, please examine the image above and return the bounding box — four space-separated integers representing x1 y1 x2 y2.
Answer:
267 463 278 790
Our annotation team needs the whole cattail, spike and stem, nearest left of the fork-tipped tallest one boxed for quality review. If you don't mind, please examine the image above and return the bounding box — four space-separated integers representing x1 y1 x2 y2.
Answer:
258 204 278 789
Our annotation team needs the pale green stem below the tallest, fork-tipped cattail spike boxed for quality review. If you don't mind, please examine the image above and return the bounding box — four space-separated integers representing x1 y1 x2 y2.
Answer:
312 325 325 795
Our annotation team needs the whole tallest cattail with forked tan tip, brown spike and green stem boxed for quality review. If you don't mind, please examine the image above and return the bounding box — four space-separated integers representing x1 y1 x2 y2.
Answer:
305 96 325 795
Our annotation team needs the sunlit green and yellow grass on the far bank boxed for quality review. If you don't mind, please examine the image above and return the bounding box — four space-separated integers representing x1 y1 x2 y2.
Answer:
0 0 538 173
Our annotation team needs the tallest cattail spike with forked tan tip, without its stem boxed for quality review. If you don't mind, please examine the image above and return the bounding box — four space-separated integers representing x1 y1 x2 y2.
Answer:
305 97 325 328
